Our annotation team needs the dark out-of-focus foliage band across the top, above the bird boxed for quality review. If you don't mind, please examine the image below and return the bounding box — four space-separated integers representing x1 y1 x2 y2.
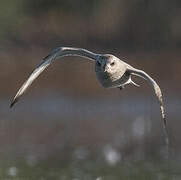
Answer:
0 0 181 51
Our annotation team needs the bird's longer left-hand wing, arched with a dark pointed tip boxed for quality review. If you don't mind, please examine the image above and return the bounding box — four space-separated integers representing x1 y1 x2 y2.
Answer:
10 47 98 107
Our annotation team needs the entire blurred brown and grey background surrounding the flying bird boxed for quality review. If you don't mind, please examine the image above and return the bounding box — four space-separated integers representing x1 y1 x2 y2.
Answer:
0 0 181 180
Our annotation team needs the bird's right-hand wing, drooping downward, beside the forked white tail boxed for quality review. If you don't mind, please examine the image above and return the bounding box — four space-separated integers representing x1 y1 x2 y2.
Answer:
127 66 169 144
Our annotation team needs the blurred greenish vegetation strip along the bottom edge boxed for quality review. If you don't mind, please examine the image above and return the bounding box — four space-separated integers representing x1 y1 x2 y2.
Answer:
0 159 181 180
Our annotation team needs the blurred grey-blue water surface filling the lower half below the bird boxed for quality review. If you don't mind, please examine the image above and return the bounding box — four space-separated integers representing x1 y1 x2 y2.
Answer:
0 93 181 179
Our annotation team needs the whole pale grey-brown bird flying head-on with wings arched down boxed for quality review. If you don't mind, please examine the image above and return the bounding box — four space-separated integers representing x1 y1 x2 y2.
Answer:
10 47 168 143
